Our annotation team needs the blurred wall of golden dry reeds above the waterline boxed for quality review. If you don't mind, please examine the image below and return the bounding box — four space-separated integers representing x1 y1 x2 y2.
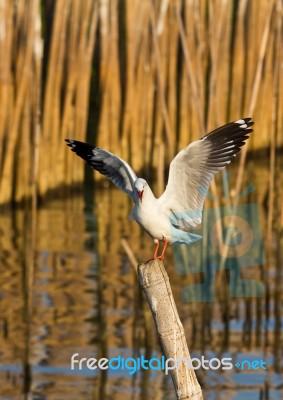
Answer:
0 0 283 203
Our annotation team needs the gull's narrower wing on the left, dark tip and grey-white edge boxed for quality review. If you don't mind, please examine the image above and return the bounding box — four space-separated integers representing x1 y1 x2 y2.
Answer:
65 139 137 200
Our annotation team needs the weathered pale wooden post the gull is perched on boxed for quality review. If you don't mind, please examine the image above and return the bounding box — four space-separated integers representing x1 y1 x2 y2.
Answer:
138 260 203 400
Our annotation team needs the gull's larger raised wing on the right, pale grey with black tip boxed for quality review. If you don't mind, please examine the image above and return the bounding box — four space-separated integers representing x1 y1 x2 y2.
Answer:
158 118 253 229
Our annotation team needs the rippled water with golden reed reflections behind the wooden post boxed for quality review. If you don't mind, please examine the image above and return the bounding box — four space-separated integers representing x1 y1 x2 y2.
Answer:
0 155 283 400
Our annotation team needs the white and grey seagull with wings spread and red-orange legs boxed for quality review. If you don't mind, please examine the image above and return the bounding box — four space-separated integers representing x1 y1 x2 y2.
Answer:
65 118 254 260
